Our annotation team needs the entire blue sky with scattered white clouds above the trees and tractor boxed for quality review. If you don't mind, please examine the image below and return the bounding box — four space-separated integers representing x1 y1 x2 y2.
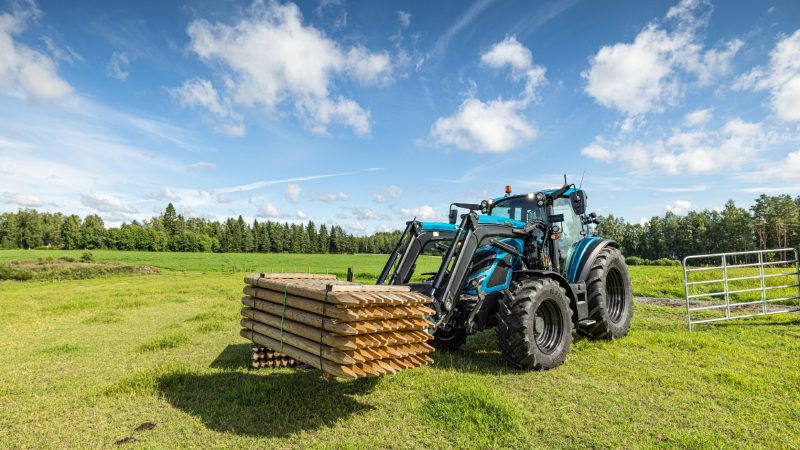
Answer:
0 0 800 234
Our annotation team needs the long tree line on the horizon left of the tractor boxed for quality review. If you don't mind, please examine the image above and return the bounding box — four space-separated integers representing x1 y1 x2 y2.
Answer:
0 203 400 253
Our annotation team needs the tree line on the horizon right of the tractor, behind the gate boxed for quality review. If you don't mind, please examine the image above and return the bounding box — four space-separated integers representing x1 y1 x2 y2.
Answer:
597 195 800 260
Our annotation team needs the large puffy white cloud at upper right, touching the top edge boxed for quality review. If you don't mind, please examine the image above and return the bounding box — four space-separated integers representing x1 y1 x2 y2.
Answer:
581 0 743 116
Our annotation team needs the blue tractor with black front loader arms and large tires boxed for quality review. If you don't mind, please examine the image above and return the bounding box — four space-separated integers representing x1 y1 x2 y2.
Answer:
378 184 633 370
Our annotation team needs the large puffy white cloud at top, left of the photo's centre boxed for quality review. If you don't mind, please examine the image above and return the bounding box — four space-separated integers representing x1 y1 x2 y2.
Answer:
182 1 392 135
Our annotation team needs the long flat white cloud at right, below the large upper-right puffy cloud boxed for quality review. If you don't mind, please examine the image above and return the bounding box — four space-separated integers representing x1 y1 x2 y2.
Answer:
582 118 774 175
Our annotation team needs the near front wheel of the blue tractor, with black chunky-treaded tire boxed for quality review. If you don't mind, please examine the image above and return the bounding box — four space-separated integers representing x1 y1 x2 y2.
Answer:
495 278 572 370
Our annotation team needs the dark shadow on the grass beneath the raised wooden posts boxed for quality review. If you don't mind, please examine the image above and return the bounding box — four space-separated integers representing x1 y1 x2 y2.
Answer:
157 370 377 437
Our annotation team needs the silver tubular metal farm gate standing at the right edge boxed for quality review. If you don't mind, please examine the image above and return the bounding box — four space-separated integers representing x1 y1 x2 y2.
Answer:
683 248 800 331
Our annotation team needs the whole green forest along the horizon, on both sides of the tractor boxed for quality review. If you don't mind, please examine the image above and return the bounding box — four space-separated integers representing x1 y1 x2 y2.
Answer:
0 195 800 260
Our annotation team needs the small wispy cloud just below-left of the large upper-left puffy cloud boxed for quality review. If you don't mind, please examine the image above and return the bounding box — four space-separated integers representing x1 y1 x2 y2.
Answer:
169 78 245 137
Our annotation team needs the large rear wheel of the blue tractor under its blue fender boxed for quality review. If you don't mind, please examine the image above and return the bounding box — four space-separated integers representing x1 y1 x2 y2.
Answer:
578 247 633 340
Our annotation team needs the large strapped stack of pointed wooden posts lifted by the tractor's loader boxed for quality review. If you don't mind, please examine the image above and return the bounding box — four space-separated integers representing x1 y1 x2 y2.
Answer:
241 274 434 378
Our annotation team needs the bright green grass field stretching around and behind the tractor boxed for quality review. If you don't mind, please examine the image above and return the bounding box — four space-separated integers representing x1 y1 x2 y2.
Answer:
0 251 800 448
